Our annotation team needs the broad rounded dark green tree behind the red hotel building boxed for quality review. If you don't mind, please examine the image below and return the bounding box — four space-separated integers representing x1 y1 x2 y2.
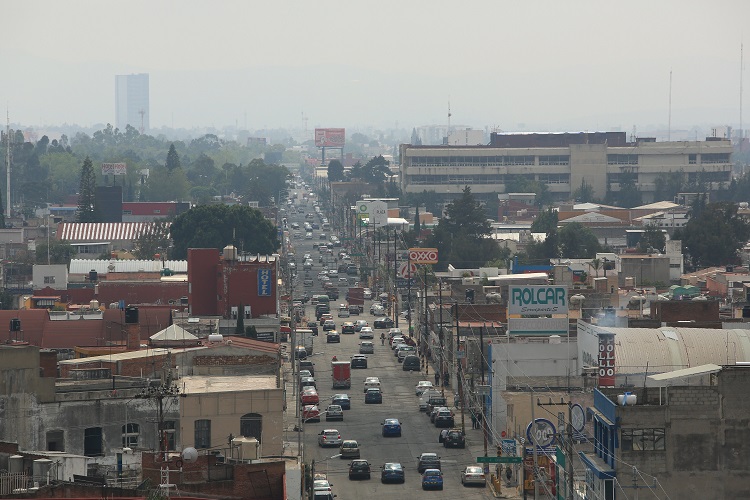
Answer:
170 204 279 259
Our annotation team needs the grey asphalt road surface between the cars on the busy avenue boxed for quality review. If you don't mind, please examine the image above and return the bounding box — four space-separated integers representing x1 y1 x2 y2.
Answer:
282 193 493 500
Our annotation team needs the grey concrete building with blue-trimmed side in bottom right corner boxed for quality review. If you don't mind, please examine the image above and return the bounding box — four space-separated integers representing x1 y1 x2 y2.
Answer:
579 365 750 500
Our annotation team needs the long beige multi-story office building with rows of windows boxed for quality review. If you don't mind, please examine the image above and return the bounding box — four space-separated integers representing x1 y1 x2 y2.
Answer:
400 132 732 203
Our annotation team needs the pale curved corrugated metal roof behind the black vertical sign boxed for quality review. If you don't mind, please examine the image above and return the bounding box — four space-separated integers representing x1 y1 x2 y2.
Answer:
601 327 750 375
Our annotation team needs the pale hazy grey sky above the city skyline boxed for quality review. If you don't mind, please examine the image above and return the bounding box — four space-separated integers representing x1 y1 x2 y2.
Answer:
0 0 750 132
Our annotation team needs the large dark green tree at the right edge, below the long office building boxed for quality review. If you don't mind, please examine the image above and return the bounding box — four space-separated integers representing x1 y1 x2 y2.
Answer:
674 202 750 267
